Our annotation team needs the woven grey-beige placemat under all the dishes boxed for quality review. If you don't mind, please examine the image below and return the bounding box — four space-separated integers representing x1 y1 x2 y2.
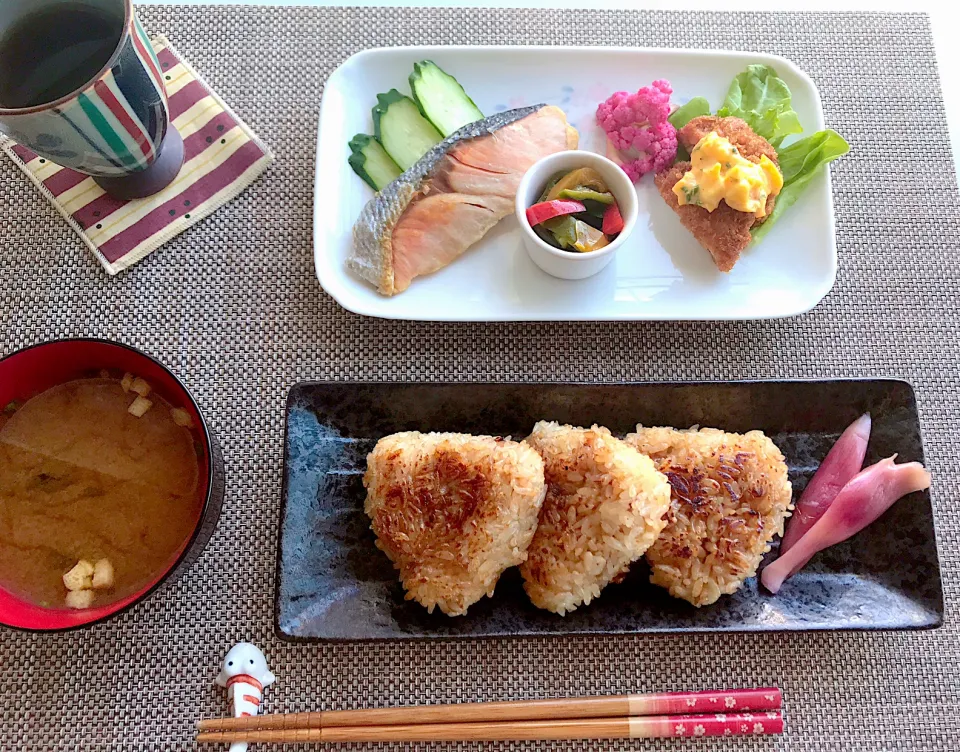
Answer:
0 6 960 752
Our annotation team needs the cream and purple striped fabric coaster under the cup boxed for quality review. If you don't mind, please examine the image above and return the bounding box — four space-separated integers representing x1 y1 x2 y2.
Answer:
0 36 274 274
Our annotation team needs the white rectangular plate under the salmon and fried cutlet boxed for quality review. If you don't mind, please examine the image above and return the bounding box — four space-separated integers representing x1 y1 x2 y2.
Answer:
314 47 837 321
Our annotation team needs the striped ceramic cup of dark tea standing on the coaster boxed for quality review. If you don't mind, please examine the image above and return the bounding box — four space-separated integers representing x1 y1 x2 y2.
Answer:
0 0 183 199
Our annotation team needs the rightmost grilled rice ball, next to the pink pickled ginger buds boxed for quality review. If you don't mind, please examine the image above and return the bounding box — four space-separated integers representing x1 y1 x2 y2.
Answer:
625 426 793 606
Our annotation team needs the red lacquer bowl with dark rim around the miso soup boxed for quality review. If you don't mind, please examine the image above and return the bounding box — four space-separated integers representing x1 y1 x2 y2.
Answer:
0 339 224 632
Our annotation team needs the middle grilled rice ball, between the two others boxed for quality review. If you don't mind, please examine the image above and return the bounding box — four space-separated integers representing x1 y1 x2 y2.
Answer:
520 422 670 616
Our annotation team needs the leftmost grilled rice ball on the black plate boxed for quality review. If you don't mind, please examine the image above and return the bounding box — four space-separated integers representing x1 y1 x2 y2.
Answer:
363 432 546 616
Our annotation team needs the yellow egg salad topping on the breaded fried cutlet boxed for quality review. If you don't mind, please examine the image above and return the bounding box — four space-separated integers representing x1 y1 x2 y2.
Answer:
673 131 783 217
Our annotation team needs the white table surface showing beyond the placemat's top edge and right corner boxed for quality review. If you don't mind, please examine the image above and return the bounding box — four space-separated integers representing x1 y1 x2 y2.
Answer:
138 0 960 173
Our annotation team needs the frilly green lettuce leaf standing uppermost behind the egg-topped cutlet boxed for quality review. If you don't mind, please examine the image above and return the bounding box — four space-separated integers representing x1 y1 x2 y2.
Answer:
717 65 803 148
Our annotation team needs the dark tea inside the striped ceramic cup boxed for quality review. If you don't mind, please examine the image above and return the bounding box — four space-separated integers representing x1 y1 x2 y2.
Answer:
0 2 124 109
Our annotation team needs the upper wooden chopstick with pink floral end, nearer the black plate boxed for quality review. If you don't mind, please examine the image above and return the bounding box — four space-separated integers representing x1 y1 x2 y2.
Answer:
197 687 783 731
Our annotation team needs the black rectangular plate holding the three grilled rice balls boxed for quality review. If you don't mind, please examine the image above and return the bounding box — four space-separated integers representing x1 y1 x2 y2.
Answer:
276 380 943 640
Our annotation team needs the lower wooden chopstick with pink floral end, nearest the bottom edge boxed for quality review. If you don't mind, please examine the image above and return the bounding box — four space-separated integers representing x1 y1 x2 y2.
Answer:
197 710 783 744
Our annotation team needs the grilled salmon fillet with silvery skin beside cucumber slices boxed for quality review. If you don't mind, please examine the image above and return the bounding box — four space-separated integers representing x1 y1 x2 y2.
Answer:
347 104 579 296
